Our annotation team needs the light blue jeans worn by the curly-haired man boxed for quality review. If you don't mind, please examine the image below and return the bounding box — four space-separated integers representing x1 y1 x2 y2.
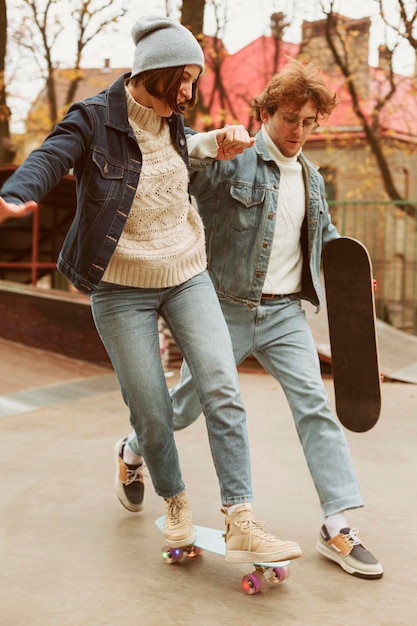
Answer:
171 296 363 515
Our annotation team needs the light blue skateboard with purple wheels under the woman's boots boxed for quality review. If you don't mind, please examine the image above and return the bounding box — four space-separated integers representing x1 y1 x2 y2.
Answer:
155 515 290 595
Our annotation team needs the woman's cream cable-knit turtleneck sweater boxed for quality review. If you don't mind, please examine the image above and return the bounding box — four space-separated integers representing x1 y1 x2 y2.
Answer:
103 90 207 288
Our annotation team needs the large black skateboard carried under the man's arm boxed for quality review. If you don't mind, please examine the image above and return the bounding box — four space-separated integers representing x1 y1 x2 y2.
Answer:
323 237 381 432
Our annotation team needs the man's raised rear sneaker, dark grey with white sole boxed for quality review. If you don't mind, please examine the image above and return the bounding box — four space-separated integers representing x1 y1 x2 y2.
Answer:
114 437 145 513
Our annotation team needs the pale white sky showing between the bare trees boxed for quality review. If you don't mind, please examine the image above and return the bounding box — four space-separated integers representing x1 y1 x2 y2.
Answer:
6 0 415 132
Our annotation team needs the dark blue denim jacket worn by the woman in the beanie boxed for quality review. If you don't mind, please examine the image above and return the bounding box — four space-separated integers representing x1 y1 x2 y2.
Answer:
0 74 188 294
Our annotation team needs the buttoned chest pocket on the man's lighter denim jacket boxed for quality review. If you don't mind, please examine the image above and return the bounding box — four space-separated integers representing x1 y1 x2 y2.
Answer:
229 185 265 231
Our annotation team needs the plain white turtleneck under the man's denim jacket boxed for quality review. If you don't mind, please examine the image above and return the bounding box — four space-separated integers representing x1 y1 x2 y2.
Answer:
262 126 305 295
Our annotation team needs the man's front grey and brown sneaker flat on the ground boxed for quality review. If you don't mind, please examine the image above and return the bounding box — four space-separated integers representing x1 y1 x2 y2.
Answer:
316 524 384 578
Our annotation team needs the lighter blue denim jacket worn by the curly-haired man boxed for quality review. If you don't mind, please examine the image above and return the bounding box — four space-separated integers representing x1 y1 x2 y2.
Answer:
186 129 339 307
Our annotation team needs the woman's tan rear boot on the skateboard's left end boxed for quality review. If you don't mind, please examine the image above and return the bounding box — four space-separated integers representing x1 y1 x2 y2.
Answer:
164 490 196 548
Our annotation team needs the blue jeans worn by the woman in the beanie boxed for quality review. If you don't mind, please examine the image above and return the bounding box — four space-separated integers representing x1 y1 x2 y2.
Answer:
92 271 253 504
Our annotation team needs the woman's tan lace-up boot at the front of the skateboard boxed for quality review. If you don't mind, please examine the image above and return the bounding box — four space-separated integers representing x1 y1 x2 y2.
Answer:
222 503 302 563
